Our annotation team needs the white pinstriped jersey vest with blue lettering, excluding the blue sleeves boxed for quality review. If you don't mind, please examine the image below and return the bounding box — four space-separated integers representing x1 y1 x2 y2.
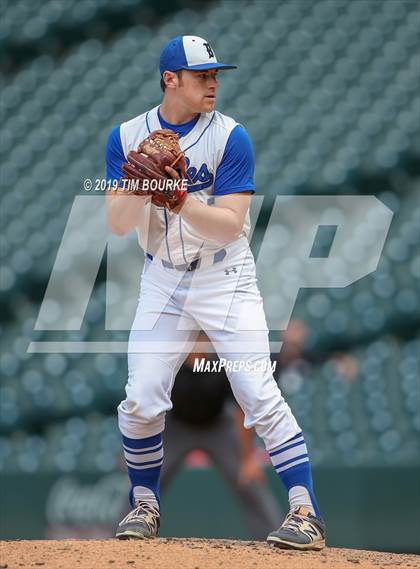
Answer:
120 107 250 265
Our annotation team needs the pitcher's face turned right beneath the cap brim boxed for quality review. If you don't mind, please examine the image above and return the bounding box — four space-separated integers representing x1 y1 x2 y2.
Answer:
178 69 219 113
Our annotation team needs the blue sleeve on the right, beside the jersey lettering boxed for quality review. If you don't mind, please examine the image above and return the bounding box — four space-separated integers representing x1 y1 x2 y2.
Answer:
213 125 255 196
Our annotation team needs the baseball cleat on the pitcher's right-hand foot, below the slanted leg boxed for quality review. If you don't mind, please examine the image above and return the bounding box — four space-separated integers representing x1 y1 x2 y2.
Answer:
267 506 325 551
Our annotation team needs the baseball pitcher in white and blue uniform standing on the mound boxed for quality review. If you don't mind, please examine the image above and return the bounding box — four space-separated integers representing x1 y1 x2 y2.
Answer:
107 36 325 550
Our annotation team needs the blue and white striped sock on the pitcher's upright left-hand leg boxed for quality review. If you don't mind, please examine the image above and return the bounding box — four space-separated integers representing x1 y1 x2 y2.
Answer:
123 433 163 508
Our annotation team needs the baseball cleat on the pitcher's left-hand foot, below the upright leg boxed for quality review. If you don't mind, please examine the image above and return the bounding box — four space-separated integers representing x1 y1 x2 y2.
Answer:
115 502 160 539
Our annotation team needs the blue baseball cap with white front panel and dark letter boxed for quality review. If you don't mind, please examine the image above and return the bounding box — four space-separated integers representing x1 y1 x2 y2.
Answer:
160 36 237 75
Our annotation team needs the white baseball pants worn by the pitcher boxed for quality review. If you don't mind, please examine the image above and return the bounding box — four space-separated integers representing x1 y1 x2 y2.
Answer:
118 238 300 451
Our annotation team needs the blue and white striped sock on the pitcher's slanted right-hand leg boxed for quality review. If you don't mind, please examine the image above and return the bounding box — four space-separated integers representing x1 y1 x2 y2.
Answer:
269 432 321 518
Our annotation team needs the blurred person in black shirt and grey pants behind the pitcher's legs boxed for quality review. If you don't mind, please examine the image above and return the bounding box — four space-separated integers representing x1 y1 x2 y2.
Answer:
161 332 280 540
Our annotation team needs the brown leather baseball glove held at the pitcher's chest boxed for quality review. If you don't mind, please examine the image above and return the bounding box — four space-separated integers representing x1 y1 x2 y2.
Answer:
122 129 187 211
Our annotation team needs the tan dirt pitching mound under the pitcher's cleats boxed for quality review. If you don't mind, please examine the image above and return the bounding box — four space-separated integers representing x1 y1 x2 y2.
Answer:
0 538 420 569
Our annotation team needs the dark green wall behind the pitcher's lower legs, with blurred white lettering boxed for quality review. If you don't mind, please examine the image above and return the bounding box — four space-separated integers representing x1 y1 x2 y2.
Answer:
0 468 420 552
